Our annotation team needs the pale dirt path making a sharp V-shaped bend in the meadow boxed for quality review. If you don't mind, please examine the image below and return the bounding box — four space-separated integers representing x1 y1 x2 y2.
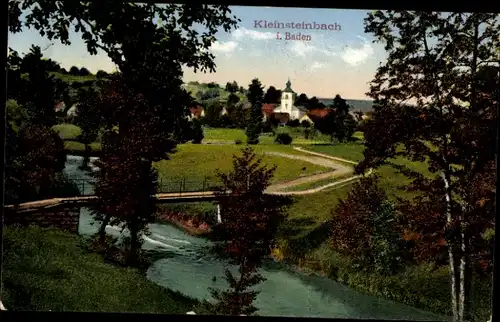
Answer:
265 150 353 195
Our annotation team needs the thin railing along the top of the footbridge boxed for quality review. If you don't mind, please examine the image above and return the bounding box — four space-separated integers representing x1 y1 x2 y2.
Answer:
70 176 224 196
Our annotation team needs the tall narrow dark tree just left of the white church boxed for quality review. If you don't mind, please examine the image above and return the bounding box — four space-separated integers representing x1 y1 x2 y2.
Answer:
246 78 264 144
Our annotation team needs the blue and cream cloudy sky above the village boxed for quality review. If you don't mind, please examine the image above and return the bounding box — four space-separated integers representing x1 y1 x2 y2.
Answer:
8 6 386 99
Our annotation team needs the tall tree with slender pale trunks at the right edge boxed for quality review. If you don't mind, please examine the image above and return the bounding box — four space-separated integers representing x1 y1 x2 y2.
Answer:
358 11 500 321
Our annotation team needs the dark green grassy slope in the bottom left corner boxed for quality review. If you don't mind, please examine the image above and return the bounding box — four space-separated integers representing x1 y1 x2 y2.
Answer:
1 227 197 314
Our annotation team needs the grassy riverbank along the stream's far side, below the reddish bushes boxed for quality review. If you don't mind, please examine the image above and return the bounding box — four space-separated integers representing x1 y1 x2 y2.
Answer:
160 207 491 322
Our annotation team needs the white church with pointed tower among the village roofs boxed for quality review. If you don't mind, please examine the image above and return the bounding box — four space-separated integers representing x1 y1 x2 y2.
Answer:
263 79 307 123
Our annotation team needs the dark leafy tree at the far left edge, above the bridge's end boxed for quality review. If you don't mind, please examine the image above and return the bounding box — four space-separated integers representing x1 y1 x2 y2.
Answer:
5 46 70 203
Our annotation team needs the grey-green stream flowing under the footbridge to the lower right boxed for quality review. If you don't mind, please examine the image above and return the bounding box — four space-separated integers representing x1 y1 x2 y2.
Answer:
65 156 444 321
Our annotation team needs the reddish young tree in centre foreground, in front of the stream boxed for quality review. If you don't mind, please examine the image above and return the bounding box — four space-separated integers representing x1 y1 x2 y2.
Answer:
212 147 286 315
